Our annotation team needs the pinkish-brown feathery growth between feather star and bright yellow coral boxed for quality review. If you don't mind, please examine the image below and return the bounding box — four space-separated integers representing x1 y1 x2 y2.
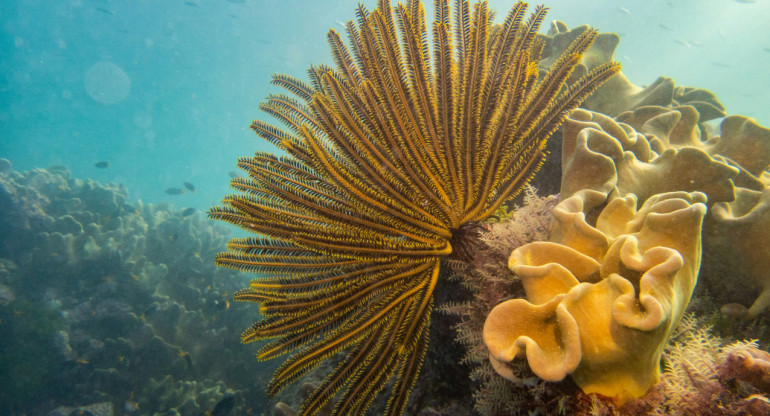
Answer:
439 188 575 415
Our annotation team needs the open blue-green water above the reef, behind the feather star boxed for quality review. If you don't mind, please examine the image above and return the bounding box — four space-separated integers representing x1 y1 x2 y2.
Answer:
0 0 770 210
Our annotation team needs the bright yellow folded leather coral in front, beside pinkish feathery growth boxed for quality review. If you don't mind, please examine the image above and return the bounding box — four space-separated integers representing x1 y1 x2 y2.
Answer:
483 190 706 402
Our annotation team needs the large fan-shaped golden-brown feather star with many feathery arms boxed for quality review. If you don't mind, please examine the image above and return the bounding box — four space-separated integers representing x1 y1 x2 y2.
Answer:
209 0 619 415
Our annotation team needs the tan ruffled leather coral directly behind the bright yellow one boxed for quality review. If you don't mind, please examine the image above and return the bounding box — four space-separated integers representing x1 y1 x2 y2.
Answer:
561 106 770 319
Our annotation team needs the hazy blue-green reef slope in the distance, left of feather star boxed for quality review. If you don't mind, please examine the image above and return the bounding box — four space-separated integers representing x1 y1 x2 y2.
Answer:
0 160 258 415
